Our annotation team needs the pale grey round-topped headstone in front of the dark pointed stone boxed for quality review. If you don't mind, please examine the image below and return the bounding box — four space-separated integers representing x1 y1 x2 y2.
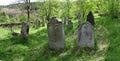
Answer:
78 11 94 48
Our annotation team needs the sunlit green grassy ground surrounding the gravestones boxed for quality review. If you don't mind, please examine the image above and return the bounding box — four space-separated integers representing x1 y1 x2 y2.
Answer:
0 17 120 61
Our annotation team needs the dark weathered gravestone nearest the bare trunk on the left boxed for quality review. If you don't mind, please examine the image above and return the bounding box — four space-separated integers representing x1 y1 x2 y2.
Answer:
21 22 29 39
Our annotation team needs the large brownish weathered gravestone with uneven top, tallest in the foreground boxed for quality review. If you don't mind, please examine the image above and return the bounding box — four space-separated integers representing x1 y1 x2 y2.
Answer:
47 17 65 49
